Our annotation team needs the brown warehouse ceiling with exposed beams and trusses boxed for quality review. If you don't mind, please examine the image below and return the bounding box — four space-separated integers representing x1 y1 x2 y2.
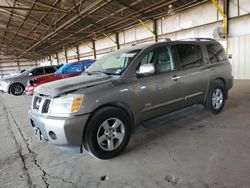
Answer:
0 0 205 59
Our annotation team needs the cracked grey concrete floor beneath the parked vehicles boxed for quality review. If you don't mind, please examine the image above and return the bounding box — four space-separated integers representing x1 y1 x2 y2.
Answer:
0 81 250 188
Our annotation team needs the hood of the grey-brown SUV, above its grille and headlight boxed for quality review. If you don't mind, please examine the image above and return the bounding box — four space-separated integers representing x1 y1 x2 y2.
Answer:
35 75 111 97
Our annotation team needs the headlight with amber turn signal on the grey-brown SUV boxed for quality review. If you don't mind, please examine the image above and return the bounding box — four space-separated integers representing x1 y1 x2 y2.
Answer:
50 94 84 114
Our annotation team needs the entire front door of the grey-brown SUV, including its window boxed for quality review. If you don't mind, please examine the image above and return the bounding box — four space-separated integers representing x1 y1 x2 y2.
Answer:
135 45 184 120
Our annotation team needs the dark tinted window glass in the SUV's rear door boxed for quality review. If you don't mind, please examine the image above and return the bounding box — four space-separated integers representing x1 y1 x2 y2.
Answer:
176 44 202 69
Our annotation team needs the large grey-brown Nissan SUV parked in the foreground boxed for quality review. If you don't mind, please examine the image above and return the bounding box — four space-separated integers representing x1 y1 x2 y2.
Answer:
29 39 233 159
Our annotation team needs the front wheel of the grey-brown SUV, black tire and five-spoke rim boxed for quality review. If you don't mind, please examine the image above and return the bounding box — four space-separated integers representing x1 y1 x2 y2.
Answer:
84 107 131 159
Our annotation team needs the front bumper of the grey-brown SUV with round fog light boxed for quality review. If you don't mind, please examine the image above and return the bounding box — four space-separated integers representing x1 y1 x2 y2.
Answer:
29 110 90 153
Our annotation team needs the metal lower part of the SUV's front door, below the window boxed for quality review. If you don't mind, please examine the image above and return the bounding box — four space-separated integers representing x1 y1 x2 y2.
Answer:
136 71 184 119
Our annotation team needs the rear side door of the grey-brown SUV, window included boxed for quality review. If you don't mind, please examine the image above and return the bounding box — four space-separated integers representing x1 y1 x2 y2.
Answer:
175 44 210 105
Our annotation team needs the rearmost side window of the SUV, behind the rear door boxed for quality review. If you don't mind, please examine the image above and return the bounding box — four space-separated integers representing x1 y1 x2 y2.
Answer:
207 44 227 63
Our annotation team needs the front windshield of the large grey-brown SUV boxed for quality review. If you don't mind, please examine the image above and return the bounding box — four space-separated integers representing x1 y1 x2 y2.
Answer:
86 50 140 75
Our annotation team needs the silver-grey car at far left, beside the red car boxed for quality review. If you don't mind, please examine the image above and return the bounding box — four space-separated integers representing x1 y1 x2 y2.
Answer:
0 65 61 95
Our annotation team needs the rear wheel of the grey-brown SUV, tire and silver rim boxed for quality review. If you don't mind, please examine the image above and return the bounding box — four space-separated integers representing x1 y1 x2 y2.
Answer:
206 80 226 114
